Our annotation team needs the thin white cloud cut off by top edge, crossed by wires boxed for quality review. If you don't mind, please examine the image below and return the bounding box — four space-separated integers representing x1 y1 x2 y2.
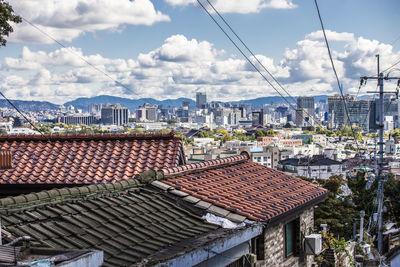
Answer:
164 0 297 14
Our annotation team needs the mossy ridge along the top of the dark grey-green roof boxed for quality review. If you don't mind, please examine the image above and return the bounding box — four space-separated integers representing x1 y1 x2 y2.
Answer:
0 179 142 214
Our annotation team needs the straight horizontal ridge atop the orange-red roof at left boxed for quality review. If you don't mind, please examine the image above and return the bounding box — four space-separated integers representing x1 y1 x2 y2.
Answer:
0 131 180 141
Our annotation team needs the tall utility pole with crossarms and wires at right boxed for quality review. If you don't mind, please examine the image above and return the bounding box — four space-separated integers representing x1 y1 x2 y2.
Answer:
361 55 400 255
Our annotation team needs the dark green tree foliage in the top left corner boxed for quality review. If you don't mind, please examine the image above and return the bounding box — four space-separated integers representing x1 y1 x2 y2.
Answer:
0 0 22 46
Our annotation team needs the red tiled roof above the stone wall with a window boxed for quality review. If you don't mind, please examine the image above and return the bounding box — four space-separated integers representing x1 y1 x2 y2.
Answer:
162 154 327 221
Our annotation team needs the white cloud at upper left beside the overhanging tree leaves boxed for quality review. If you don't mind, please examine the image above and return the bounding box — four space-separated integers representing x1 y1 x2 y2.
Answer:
8 0 170 43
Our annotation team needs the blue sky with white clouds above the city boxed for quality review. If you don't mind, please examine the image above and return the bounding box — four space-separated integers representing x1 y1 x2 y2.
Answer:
0 0 400 104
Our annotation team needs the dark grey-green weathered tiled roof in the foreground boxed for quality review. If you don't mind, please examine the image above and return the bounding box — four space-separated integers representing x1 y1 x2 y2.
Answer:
0 177 219 266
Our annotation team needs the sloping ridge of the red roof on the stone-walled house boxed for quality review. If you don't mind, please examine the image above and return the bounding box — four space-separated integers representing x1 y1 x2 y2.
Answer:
161 151 250 178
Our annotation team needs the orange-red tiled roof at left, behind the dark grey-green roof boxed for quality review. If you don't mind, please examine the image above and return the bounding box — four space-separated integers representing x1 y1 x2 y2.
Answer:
0 133 185 184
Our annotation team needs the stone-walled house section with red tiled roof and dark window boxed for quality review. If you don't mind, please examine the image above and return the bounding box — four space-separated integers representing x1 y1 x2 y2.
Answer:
154 153 327 266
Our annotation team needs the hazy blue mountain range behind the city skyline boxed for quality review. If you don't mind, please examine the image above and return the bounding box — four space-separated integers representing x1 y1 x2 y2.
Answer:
0 95 365 111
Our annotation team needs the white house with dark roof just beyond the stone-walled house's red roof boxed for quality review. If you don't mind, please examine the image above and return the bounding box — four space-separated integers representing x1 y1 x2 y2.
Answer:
277 155 344 179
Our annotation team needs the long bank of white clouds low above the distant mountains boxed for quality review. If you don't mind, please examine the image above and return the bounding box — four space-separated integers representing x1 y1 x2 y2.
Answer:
0 31 400 103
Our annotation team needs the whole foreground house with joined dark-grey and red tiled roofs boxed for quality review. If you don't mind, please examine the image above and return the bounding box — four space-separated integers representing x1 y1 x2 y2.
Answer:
0 153 327 266
